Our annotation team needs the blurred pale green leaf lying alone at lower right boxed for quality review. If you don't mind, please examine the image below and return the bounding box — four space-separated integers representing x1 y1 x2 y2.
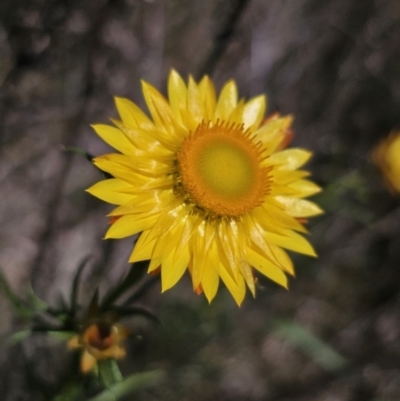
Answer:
273 320 348 371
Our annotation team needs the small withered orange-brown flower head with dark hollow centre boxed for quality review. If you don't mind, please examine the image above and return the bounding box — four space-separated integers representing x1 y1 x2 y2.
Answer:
68 322 128 373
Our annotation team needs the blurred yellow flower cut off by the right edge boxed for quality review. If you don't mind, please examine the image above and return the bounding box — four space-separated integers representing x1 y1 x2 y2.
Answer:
372 131 400 192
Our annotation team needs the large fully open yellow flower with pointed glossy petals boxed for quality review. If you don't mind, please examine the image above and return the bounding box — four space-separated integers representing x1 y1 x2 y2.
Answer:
88 71 321 305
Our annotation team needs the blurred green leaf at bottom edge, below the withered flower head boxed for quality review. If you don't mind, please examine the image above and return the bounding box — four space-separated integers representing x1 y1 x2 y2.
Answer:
87 370 164 401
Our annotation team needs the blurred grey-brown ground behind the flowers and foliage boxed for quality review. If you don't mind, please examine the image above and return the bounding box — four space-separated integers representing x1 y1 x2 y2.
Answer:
0 0 400 401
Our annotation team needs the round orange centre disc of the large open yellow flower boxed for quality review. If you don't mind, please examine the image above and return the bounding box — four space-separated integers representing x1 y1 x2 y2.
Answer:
178 123 270 217
